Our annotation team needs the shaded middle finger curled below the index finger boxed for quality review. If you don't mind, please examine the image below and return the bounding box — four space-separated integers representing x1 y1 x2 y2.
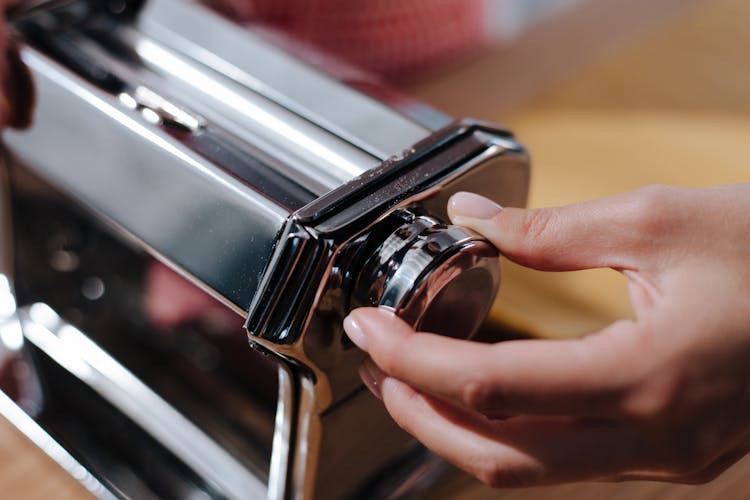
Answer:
381 377 639 487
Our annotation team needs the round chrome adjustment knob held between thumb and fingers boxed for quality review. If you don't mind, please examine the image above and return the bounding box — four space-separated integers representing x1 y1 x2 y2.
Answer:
354 213 500 338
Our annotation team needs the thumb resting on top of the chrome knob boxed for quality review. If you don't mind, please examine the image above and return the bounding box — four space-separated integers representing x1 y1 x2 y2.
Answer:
448 188 671 271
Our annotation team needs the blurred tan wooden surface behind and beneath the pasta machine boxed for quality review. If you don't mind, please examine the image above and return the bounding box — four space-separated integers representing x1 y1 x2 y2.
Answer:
0 0 750 500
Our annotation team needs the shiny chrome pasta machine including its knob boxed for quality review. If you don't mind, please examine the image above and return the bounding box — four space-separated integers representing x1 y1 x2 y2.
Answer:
5 0 529 498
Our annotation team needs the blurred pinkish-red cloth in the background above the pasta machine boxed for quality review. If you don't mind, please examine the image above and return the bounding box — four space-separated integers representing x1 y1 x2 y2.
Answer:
206 0 487 78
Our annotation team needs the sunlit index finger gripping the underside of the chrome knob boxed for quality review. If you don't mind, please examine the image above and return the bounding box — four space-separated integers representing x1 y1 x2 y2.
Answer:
344 308 639 416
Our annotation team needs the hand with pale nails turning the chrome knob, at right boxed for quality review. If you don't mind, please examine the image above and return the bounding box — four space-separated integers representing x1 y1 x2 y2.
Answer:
345 184 750 487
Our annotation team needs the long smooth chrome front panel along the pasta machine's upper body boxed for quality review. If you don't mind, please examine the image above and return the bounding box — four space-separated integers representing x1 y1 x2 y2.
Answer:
5 49 288 308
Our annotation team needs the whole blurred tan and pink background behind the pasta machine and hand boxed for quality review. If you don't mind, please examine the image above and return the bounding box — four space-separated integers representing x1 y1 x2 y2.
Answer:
7 0 750 499
